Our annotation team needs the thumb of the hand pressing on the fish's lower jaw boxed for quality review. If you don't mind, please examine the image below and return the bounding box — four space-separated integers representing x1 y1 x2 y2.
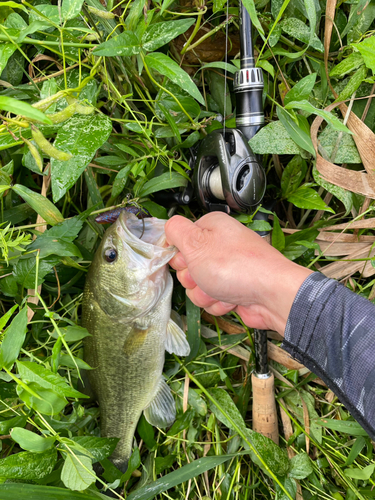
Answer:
165 215 208 262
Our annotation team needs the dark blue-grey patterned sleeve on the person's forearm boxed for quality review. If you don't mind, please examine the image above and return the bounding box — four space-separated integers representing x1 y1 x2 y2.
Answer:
282 273 375 439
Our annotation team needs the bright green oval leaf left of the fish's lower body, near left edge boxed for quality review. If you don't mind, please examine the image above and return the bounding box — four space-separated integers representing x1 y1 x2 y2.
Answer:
17 382 68 415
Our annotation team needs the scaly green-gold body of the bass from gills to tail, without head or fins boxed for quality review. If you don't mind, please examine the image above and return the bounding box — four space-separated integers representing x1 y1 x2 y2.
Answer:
83 287 171 471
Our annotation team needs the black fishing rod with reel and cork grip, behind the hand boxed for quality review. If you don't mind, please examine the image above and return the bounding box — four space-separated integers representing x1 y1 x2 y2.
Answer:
156 1 279 443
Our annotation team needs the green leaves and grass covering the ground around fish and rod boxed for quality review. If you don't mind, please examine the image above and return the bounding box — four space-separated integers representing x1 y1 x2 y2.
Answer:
0 0 375 500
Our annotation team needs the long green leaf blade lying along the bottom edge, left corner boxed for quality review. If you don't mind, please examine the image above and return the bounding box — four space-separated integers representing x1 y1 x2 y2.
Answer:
0 484 108 500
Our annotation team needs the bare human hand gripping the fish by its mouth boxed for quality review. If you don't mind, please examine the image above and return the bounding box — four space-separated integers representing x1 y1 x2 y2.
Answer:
165 212 312 334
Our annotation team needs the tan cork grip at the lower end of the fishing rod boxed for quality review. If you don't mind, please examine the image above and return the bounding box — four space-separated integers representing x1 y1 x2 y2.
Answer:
251 374 279 444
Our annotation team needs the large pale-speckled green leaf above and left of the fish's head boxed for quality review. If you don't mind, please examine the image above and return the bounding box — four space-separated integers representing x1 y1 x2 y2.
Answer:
51 114 112 202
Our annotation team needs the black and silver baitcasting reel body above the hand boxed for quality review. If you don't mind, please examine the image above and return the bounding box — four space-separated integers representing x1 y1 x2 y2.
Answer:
193 129 266 213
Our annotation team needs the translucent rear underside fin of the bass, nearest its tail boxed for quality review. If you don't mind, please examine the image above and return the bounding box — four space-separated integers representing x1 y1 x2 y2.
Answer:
143 378 176 427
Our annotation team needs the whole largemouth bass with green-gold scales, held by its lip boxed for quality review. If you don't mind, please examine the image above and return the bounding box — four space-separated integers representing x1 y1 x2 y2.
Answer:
82 211 190 471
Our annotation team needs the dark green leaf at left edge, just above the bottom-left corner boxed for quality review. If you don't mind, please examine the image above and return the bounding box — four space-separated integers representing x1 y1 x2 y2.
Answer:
0 449 57 480
